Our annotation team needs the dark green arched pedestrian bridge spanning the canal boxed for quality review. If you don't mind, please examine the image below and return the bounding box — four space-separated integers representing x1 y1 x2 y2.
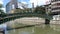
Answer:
0 13 51 23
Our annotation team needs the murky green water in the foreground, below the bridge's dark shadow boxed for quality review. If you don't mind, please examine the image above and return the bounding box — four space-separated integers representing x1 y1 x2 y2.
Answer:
8 24 60 34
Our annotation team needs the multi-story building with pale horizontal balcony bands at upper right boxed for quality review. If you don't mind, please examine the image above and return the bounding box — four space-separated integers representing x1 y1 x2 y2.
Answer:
51 0 60 15
